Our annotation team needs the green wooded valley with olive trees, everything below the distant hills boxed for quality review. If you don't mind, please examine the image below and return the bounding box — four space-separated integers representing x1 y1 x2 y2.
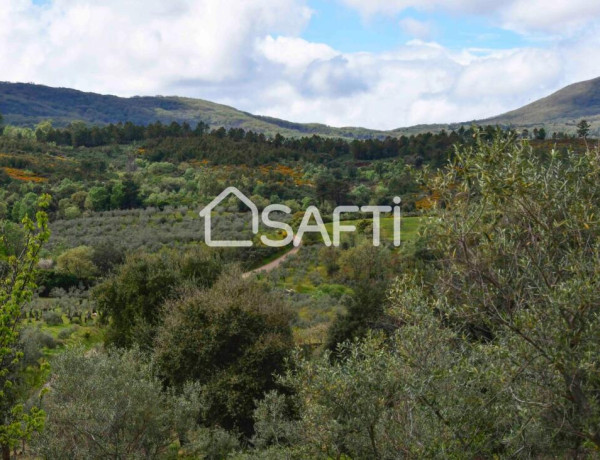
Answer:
0 113 600 459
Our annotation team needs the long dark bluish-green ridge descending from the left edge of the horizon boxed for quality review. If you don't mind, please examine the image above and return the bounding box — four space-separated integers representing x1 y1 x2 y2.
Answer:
0 82 386 138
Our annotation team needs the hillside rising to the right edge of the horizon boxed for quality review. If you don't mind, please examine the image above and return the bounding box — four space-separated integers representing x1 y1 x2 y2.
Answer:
478 78 600 134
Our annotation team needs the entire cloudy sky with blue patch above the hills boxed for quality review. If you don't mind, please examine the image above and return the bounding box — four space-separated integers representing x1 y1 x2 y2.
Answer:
0 0 600 129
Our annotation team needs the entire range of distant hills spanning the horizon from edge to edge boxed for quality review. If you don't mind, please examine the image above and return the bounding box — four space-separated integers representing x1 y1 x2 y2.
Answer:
0 78 600 139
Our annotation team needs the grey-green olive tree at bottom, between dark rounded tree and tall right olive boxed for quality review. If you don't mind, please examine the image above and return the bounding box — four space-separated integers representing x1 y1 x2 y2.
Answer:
264 326 512 459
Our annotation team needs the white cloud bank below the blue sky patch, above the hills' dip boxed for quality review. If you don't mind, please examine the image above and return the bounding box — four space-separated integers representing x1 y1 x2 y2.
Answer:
245 33 600 129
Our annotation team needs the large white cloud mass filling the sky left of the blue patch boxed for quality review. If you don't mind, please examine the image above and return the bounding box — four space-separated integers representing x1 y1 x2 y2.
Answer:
0 0 311 94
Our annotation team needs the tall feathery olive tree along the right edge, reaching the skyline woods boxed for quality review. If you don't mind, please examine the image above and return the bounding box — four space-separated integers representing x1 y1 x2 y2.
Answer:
420 130 600 452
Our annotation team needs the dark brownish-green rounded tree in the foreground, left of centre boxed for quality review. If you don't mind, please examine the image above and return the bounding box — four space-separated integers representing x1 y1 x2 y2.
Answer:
155 272 293 436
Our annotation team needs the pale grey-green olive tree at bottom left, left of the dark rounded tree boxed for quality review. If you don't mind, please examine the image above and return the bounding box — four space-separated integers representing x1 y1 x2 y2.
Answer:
33 349 200 458
